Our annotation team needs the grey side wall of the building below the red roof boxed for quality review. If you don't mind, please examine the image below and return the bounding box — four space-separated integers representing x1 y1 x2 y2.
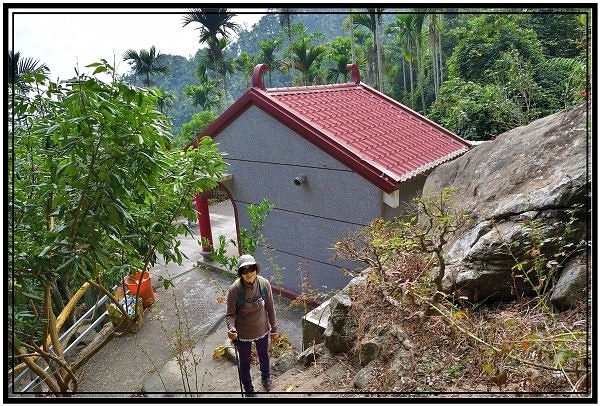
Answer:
214 106 418 292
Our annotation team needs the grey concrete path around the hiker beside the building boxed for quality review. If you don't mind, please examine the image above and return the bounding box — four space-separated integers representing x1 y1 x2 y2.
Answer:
76 202 305 398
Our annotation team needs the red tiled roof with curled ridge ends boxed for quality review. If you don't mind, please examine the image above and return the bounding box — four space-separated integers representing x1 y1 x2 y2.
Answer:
195 65 470 193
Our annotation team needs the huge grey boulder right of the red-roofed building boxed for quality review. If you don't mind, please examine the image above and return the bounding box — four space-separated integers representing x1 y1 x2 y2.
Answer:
423 104 591 308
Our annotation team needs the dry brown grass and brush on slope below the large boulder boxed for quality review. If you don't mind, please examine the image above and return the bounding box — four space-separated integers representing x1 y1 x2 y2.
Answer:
319 275 591 398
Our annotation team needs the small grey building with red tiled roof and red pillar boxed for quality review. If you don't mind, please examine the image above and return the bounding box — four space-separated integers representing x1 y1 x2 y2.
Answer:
194 64 470 293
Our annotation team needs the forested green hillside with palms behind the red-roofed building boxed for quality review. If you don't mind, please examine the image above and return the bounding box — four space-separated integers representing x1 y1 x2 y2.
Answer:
119 8 591 146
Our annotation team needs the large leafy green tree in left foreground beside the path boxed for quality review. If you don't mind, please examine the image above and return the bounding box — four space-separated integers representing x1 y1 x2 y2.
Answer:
7 61 225 392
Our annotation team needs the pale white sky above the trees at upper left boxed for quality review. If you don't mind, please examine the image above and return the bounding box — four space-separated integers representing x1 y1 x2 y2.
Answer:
8 5 267 80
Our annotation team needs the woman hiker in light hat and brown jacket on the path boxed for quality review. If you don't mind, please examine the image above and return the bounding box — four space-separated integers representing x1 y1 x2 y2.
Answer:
225 255 277 396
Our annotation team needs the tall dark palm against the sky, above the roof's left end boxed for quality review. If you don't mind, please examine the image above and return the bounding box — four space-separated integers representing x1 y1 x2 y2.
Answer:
183 8 240 81
